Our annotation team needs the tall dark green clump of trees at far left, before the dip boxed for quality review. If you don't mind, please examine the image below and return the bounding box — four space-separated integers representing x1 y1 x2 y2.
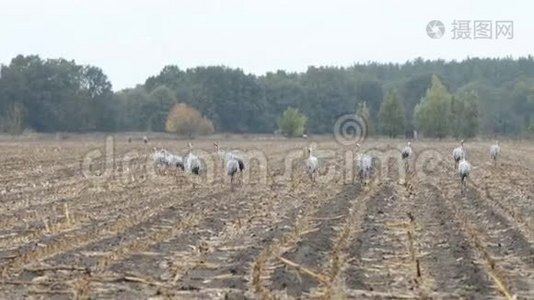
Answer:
0 55 115 132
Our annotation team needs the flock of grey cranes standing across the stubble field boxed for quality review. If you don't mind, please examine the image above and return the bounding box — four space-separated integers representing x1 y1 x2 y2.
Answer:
143 136 501 194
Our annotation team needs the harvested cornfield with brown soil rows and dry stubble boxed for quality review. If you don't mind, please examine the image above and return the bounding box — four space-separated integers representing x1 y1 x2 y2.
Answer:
0 137 534 299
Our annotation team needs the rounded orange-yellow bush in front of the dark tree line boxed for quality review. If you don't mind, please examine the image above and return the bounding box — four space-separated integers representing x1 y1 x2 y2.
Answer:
169 103 215 138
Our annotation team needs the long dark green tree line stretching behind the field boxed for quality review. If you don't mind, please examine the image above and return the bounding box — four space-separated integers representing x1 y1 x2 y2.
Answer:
0 55 534 137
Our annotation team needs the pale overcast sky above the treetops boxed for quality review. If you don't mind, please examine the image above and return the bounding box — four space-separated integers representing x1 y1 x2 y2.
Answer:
0 0 534 90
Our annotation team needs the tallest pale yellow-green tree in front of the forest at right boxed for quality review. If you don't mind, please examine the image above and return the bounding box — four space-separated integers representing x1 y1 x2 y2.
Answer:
414 75 451 138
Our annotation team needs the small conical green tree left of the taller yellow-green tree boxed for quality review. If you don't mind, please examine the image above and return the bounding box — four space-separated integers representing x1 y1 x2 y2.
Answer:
378 89 404 137
